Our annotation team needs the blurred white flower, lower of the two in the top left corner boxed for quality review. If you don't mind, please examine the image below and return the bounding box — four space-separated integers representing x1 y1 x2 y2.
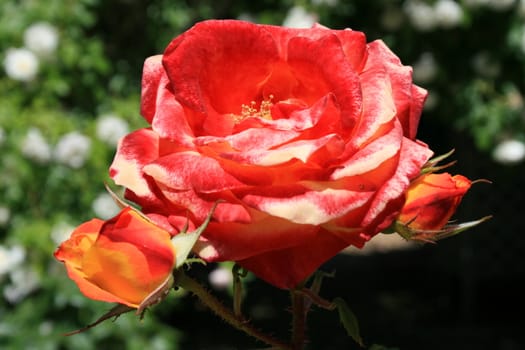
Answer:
4 48 38 81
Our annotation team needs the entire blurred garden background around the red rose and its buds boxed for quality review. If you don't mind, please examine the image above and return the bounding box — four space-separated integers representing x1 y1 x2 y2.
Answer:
0 0 525 350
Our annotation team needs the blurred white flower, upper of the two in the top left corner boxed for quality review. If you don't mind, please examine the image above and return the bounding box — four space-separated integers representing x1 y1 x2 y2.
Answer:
24 22 58 56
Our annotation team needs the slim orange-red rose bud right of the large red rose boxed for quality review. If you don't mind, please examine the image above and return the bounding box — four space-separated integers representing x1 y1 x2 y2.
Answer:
397 173 472 230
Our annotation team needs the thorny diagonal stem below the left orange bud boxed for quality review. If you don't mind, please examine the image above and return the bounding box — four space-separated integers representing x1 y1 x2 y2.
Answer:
174 269 293 350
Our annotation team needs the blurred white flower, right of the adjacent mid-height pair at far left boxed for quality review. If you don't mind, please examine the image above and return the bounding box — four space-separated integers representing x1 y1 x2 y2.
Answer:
54 131 91 168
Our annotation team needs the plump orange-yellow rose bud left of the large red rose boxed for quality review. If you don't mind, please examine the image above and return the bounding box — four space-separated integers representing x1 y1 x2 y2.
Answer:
55 207 176 308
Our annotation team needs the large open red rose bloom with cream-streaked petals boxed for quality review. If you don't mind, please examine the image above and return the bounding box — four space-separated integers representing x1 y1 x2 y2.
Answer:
110 20 432 288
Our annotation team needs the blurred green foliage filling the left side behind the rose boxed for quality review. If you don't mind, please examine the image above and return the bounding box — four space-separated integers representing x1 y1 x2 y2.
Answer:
0 0 185 350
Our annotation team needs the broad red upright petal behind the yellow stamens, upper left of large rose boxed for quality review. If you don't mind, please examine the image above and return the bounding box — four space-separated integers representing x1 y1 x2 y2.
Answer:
163 21 278 119
